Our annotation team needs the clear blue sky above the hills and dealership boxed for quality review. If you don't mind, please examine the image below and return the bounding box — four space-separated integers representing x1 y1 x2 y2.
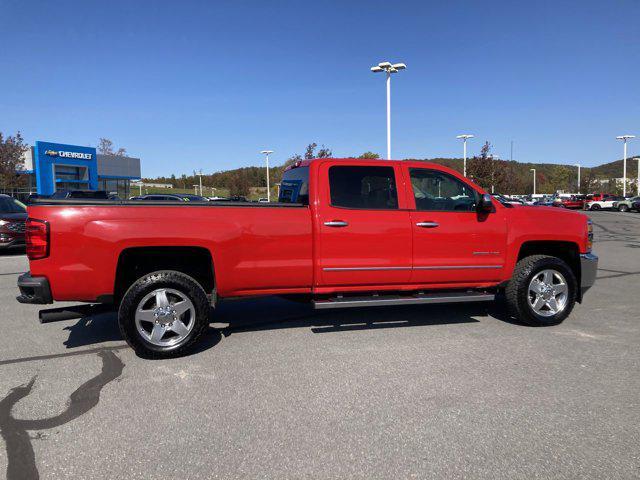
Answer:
0 0 640 176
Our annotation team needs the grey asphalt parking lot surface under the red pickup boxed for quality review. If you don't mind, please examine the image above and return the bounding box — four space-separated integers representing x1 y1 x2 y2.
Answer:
0 212 640 480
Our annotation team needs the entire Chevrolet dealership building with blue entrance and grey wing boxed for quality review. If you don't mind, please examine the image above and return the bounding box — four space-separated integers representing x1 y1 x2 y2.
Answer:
19 141 140 198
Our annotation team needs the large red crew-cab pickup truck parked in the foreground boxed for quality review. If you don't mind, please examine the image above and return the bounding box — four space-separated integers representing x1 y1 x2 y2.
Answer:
18 159 598 357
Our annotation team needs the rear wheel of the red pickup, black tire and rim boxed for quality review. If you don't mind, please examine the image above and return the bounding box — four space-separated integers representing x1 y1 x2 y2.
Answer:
118 270 210 358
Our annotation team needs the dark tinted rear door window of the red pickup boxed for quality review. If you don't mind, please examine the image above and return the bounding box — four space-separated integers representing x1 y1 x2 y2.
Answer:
329 165 398 210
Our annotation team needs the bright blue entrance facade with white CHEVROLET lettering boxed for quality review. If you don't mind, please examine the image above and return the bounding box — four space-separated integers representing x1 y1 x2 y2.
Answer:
33 141 98 195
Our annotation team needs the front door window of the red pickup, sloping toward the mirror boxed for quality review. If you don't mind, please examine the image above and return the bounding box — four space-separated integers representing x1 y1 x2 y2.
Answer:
409 168 478 212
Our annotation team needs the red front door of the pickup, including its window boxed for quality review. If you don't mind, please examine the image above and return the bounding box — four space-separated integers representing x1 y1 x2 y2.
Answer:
402 165 504 286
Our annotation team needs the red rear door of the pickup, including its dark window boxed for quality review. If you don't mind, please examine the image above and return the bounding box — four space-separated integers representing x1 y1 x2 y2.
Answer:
315 161 412 287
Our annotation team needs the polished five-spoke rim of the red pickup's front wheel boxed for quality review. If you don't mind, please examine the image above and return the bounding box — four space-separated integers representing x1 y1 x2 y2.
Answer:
528 269 569 317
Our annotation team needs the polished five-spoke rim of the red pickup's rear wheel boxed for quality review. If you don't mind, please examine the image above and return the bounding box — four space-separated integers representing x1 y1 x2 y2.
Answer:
135 288 196 347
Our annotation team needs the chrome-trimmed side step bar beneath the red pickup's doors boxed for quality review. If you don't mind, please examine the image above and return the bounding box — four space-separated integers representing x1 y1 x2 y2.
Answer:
313 292 496 310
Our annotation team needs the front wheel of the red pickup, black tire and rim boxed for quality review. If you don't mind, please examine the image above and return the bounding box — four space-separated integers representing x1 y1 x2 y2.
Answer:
505 255 577 327
